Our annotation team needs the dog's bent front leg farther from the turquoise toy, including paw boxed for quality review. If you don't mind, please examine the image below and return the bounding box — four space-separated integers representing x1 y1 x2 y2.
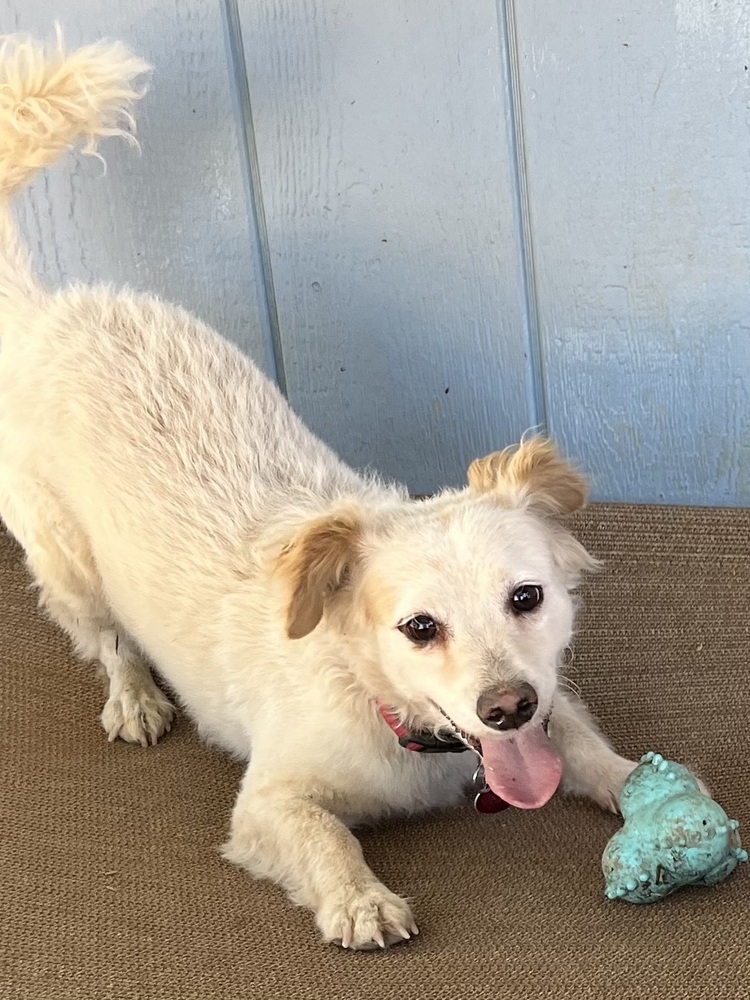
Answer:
224 766 419 949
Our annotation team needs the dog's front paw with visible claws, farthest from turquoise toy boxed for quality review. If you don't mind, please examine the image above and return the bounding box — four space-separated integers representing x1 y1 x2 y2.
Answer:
316 882 419 950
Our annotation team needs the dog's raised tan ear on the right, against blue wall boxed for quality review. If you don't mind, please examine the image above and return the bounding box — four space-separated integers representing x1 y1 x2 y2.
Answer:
468 437 588 514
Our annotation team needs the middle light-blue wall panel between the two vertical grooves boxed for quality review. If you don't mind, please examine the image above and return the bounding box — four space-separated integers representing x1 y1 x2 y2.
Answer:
239 0 530 492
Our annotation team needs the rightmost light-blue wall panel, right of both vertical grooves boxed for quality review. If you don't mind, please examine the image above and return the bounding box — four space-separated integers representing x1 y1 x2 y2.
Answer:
517 0 750 505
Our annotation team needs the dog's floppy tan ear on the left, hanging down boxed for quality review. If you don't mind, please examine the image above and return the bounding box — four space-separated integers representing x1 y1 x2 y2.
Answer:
277 508 362 639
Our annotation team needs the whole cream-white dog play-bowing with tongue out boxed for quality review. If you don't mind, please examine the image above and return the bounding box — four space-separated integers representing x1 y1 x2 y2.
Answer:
0 37 634 948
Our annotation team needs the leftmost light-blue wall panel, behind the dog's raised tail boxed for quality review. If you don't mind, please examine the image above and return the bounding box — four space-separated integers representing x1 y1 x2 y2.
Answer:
0 0 272 371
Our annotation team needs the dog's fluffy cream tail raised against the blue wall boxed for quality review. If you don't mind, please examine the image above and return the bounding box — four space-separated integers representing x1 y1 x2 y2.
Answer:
0 29 149 297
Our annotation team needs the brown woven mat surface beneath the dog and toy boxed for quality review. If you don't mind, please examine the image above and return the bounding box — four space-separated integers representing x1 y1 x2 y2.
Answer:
0 506 750 1000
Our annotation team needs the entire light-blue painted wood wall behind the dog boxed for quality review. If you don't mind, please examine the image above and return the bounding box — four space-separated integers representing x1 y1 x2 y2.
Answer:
5 0 750 505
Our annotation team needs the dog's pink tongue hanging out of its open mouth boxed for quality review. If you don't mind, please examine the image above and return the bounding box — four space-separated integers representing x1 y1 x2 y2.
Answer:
482 726 562 809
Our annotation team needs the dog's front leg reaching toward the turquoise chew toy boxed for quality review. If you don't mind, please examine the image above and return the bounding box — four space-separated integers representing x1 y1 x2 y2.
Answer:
549 691 636 812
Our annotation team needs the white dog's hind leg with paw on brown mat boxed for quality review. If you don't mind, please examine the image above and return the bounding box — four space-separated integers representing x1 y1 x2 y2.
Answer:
0 470 174 746
